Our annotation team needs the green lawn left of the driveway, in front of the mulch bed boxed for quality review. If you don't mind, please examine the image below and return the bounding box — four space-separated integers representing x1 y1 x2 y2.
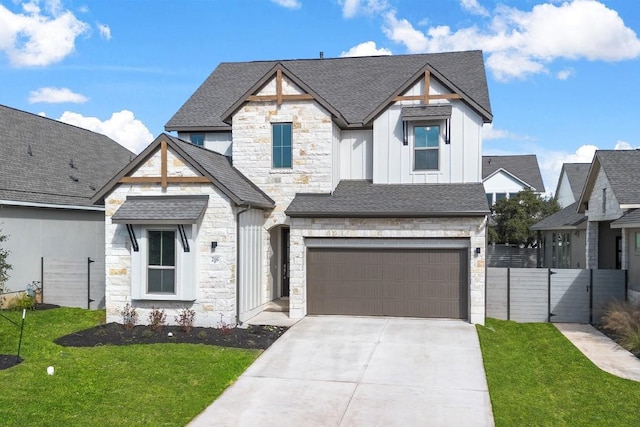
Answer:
0 308 260 427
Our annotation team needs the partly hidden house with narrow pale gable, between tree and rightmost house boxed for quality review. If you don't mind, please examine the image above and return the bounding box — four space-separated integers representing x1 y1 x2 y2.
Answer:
531 163 591 268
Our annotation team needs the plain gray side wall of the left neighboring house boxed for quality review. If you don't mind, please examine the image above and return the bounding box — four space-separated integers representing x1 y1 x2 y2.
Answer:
0 206 105 290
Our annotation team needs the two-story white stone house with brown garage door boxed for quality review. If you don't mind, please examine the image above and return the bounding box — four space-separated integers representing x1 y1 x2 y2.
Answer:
93 51 492 326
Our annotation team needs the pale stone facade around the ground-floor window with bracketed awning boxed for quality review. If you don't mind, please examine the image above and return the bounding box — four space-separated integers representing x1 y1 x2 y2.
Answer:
105 147 236 326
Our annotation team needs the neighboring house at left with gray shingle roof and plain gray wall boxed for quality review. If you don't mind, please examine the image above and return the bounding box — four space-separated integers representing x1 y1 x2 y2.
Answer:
0 102 134 305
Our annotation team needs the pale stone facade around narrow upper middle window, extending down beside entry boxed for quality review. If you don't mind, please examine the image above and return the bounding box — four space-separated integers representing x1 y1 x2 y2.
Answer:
232 78 334 303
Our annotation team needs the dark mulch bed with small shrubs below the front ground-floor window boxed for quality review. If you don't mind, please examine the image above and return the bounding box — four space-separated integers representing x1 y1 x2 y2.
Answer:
55 323 287 349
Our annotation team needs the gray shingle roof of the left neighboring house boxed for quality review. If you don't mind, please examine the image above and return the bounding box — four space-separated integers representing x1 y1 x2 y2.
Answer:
0 105 135 207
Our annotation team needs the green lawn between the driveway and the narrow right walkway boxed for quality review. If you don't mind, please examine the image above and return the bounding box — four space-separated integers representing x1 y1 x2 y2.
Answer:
478 319 640 427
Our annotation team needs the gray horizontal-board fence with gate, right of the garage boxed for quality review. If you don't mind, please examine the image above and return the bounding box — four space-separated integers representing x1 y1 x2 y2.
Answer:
487 268 627 323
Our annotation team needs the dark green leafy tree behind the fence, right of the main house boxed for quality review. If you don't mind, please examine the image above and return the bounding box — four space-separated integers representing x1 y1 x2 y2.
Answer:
489 189 560 246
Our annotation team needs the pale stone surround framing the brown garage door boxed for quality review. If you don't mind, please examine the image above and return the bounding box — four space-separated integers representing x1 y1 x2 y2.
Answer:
289 217 486 324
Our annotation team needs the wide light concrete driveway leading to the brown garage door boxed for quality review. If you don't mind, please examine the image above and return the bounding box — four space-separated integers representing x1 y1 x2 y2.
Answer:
189 316 493 427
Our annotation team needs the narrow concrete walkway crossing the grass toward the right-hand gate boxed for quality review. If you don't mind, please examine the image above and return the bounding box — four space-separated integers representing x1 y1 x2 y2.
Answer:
554 323 640 381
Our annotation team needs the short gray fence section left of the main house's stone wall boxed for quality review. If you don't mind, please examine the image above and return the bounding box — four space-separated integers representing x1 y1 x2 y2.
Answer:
42 257 105 310
